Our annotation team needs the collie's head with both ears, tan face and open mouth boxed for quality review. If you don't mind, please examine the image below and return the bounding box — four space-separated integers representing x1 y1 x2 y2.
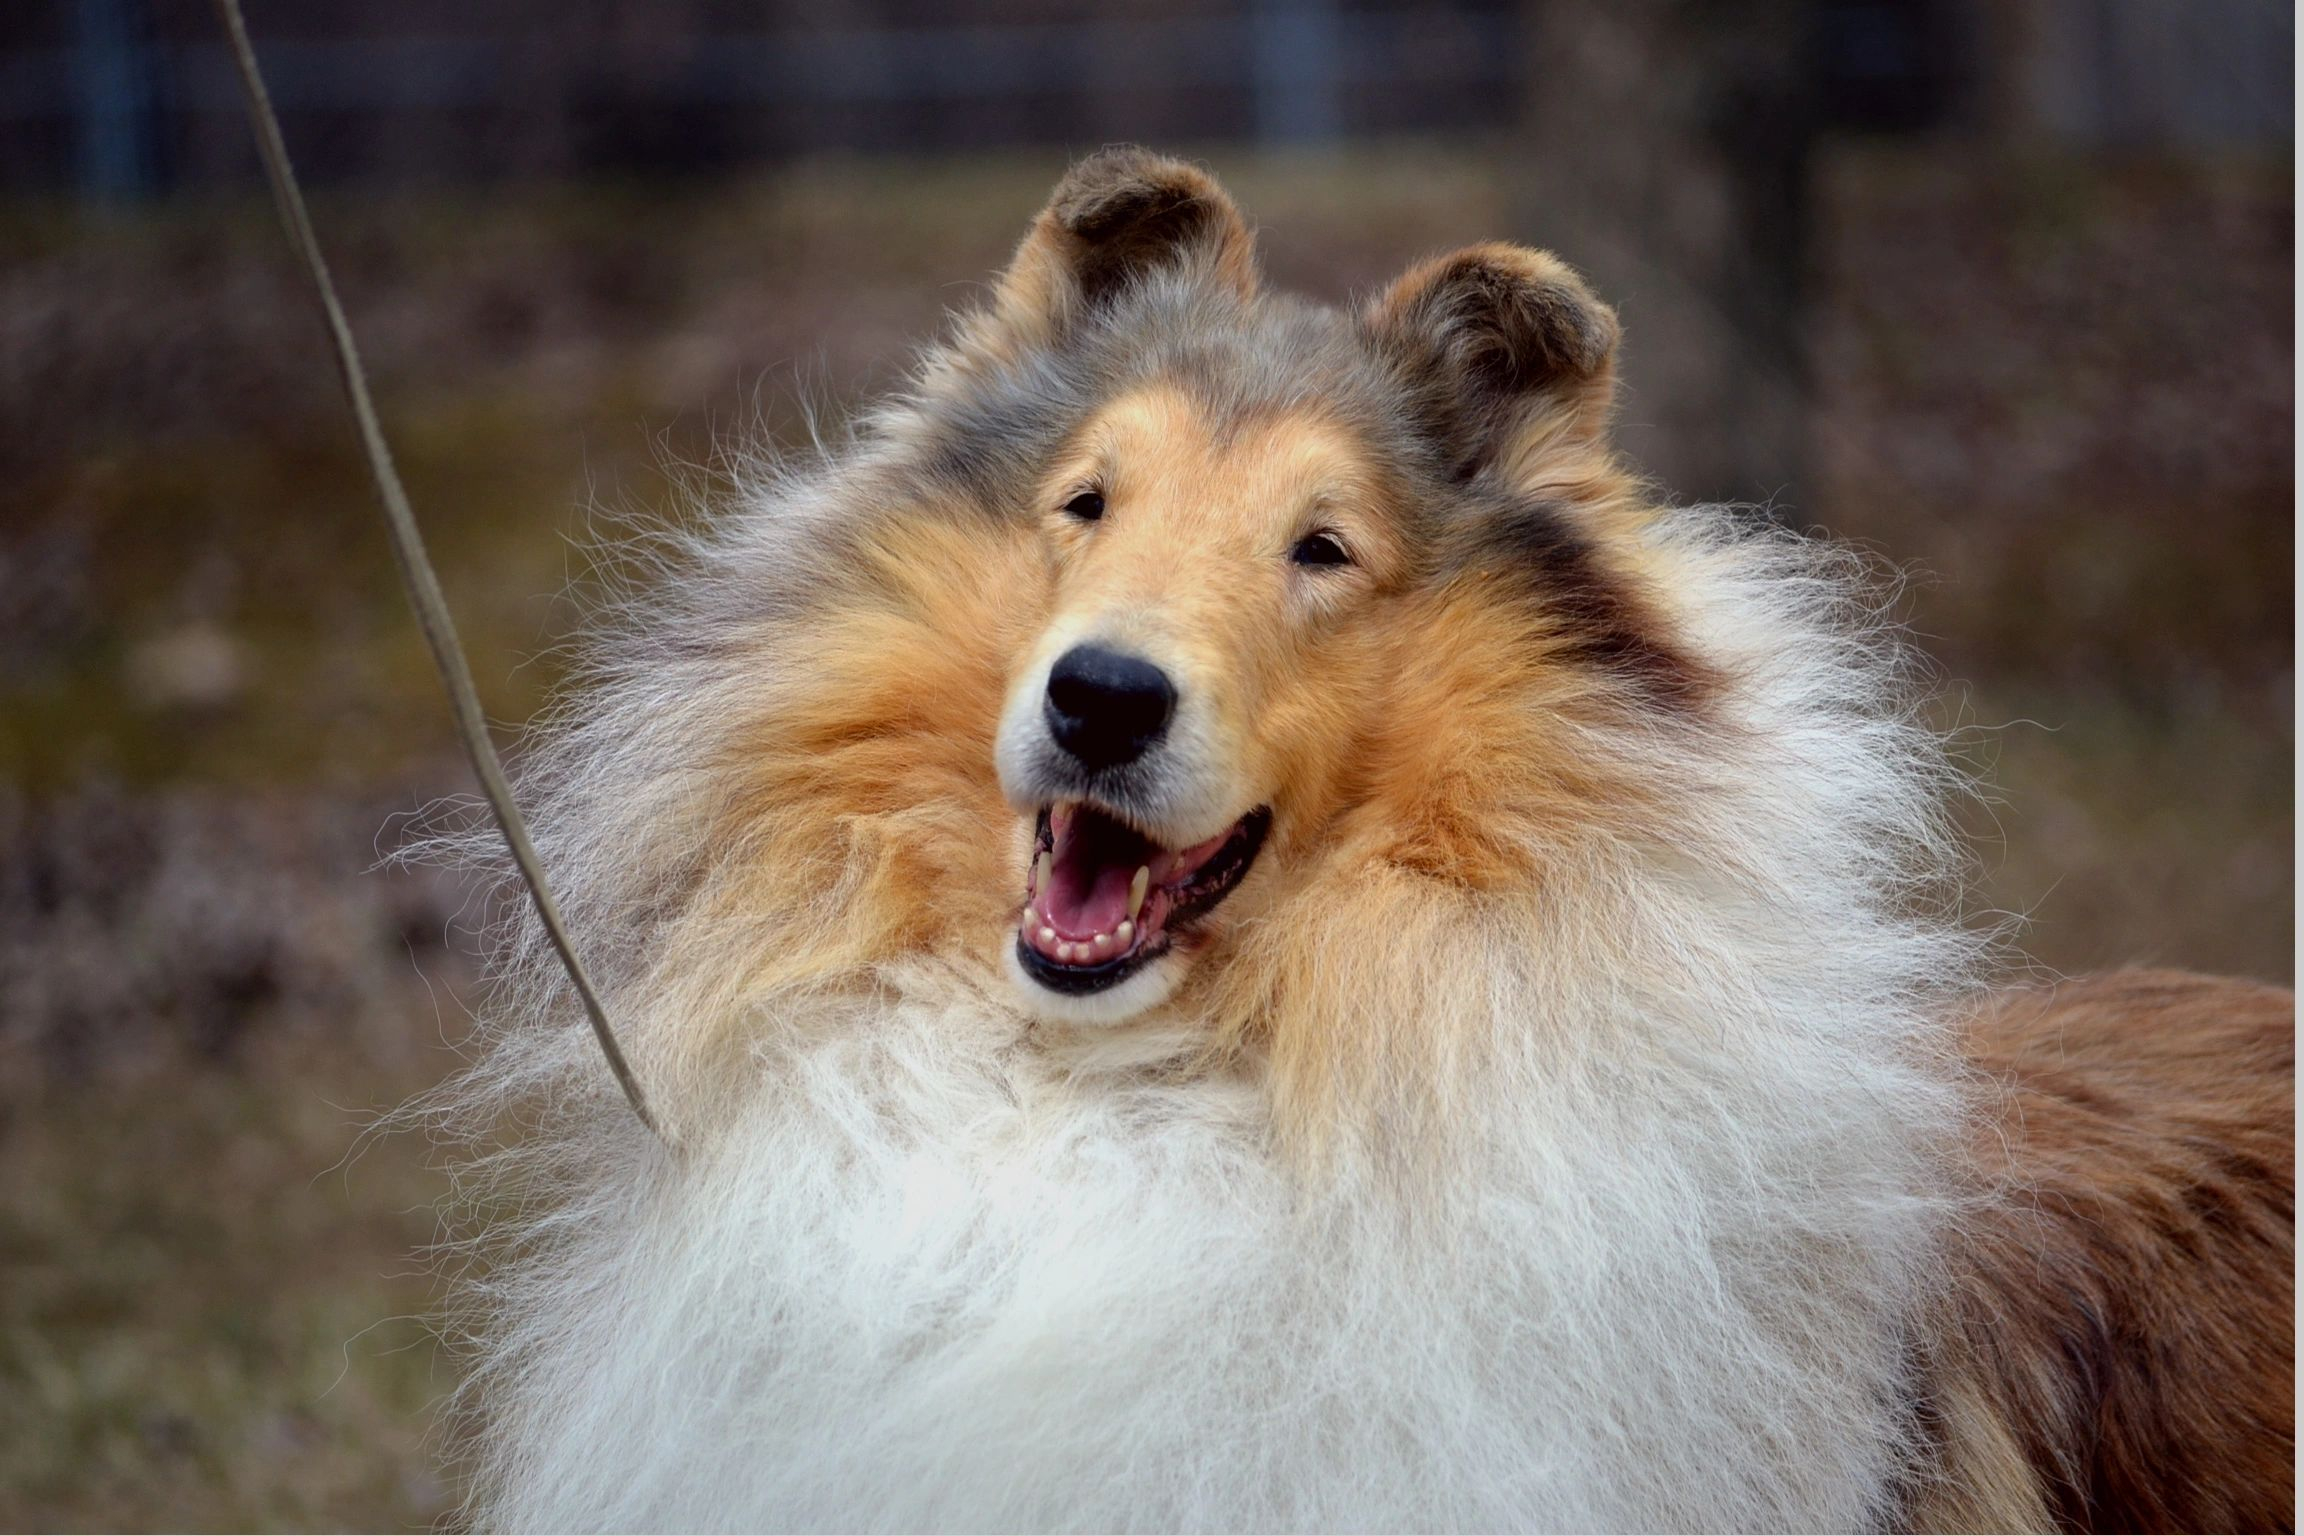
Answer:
929 150 1677 1020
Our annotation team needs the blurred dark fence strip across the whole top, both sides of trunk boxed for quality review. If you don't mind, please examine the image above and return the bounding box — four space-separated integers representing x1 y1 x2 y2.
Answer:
0 0 2295 200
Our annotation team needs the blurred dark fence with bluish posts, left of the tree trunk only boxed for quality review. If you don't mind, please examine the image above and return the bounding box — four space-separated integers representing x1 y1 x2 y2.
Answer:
0 0 1523 198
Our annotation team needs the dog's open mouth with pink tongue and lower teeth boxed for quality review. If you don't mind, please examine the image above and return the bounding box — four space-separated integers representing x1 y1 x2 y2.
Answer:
1016 801 1272 995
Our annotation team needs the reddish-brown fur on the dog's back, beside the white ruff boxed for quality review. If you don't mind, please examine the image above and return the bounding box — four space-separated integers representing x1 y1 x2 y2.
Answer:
1917 972 2295 1531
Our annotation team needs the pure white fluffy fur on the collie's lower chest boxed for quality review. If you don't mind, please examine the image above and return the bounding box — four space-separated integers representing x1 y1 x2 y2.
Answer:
475 962 1926 1529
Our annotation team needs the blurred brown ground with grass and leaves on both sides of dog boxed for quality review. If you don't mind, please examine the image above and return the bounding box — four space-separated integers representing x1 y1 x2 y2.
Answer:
0 150 2292 1529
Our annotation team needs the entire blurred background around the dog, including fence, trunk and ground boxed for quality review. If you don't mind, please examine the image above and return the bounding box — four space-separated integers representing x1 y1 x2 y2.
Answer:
0 0 2295 1529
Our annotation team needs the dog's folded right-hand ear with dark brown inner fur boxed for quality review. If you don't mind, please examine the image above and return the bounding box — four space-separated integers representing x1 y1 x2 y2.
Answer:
1362 244 1620 474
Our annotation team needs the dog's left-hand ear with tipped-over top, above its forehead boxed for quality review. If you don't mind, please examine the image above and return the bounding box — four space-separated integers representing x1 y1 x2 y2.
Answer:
993 145 1256 343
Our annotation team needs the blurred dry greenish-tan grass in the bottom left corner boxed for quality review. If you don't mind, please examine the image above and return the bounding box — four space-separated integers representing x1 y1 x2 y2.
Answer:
0 1020 452 1531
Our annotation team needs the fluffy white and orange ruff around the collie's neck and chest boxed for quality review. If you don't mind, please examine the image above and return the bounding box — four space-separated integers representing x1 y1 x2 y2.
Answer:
440 412 1975 1529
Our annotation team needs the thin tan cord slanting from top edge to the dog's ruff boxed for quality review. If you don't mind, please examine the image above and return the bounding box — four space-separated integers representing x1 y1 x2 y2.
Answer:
217 0 668 1140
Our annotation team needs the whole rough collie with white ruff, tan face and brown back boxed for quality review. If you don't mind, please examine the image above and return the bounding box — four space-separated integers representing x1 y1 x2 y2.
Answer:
452 150 2292 1531
